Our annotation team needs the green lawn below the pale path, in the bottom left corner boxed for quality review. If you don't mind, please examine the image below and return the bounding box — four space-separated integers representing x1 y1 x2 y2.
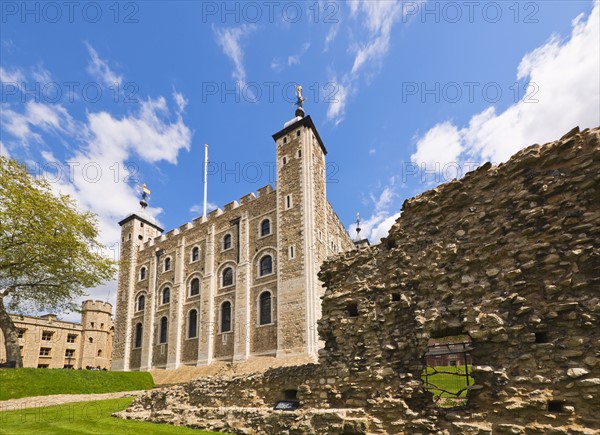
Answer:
0 397 227 435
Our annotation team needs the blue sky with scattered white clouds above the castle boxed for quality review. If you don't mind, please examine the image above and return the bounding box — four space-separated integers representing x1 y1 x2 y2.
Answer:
0 0 600 314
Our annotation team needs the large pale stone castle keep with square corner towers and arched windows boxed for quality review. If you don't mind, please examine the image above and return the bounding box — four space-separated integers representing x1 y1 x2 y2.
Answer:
113 110 354 370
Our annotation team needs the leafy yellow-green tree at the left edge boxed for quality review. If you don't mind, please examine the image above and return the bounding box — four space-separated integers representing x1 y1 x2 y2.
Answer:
0 156 116 367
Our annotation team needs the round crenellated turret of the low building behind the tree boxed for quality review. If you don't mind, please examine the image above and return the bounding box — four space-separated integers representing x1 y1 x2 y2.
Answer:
79 300 114 369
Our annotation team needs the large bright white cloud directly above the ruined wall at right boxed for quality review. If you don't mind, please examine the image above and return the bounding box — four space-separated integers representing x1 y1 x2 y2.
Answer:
411 2 600 171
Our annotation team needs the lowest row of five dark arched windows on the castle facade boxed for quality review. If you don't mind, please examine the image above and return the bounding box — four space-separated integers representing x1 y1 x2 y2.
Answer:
134 291 273 348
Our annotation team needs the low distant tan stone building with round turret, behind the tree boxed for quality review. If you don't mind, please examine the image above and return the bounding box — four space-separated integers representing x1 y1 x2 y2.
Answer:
0 300 114 369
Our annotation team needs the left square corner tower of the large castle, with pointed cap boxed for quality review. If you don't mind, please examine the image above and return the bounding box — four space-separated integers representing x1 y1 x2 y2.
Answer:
112 184 163 370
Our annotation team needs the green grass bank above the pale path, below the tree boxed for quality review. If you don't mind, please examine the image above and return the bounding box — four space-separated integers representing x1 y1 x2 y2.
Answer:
0 368 154 400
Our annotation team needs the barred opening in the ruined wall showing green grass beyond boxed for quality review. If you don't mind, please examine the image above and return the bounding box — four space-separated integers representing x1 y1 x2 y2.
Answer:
421 334 474 408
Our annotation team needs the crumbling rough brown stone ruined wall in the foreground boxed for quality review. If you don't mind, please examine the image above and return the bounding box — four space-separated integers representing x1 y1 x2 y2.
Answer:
115 124 600 434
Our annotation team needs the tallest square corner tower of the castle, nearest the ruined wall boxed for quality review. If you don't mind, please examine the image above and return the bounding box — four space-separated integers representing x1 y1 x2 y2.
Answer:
273 86 328 356
